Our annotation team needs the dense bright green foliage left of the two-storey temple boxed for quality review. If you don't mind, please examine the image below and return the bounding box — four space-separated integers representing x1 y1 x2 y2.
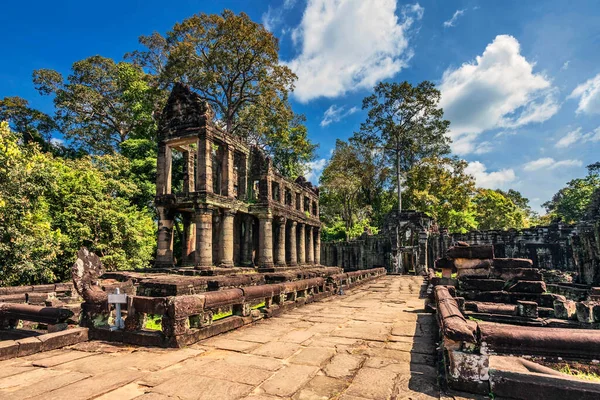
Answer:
0 123 155 285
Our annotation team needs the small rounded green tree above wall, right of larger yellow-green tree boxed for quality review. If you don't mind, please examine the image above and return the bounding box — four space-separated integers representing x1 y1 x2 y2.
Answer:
473 189 527 230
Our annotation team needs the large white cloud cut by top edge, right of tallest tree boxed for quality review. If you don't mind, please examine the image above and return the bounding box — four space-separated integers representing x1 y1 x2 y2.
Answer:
287 0 424 102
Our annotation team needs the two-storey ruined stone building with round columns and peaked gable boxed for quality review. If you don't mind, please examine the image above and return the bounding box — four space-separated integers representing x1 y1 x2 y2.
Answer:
155 84 321 269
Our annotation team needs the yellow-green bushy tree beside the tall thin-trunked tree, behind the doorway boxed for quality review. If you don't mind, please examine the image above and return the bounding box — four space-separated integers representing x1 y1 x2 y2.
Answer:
406 157 477 233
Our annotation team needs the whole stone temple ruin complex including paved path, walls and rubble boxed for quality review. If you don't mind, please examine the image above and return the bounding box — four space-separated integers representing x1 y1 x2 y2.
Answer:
0 85 600 400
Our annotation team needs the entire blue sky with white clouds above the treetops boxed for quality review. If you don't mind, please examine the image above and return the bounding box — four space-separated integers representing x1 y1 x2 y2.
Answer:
0 0 600 209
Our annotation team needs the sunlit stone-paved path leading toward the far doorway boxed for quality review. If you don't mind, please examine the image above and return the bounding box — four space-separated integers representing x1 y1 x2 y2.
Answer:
0 276 440 400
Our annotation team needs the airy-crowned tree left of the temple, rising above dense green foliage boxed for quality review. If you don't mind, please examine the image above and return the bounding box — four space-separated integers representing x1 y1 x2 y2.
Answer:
33 56 165 154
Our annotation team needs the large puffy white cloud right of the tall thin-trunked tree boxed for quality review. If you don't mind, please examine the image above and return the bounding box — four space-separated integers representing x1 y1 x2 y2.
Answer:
439 35 560 154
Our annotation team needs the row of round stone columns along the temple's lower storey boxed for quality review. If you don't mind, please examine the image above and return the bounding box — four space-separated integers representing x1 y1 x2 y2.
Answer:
156 206 321 268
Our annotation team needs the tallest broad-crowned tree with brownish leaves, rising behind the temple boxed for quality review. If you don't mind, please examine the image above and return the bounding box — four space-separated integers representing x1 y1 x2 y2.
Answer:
127 10 316 176
